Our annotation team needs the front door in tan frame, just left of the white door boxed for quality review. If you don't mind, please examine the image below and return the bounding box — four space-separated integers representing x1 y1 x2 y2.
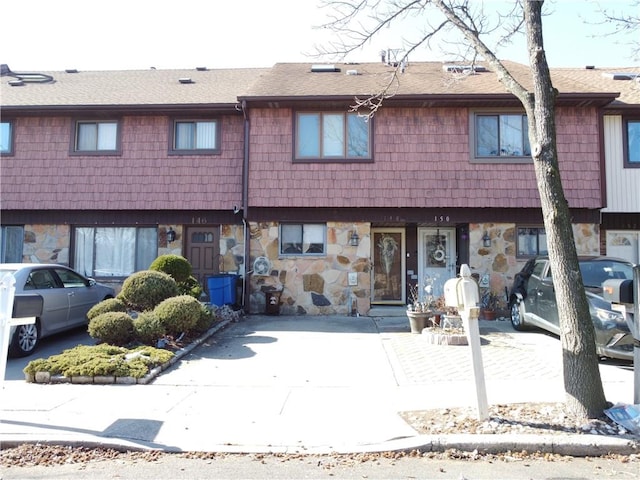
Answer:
371 228 406 305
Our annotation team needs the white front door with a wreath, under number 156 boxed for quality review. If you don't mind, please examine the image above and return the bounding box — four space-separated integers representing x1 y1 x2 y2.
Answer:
418 228 456 301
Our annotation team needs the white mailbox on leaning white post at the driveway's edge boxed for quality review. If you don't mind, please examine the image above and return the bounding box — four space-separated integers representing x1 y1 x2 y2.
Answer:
444 264 489 420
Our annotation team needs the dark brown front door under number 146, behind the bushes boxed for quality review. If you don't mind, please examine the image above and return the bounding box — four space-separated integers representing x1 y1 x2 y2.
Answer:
185 226 220 292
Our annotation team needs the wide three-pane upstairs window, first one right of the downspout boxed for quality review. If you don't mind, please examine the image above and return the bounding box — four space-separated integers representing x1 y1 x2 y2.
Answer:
295 112 371 160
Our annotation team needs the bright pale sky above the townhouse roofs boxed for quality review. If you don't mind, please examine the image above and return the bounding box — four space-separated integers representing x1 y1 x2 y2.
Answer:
0 0 640 72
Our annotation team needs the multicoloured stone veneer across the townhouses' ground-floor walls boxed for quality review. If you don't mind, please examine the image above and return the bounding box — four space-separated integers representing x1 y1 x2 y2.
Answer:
16 222 600 315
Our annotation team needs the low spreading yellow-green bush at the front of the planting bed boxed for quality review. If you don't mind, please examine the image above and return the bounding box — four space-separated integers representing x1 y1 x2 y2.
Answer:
23 344 174 378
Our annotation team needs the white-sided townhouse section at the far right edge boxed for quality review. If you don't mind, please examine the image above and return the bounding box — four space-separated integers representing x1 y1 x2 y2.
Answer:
562 67 640 263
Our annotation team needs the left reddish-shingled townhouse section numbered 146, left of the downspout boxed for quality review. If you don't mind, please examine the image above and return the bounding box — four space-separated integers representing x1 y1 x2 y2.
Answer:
0 65 261 294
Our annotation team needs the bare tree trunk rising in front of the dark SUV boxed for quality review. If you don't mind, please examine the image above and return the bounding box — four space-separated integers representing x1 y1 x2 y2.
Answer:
524 0 606 418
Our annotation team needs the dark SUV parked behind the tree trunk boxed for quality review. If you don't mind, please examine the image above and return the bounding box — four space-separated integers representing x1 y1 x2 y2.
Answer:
509 257 633 360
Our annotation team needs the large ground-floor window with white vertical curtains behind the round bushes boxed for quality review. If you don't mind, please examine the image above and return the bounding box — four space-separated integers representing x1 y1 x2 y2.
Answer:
74 227 158 277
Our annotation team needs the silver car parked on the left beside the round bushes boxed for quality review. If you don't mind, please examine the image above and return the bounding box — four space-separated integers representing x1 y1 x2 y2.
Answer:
0 263 115 357
